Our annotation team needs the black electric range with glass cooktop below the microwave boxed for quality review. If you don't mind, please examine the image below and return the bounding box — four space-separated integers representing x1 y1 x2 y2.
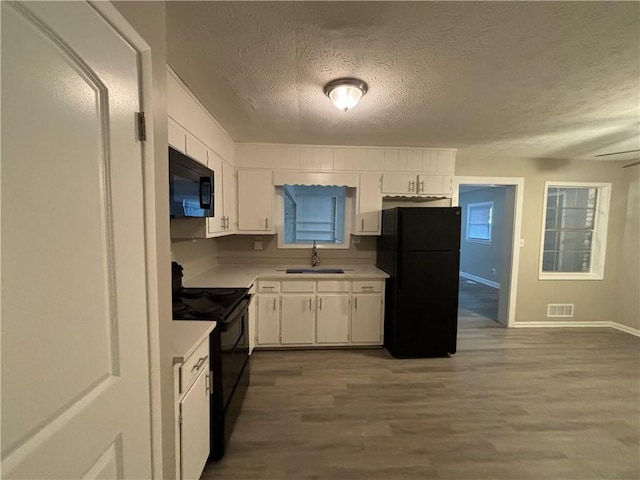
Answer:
172 262 251 460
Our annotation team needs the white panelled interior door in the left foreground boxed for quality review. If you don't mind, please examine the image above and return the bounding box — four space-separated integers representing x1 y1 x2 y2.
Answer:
1 2 151 479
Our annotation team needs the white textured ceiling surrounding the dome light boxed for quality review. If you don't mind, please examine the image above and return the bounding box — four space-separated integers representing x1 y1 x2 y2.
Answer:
167 1 640 160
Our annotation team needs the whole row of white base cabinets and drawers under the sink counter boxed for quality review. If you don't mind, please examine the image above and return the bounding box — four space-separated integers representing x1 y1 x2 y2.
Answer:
256 279 384 348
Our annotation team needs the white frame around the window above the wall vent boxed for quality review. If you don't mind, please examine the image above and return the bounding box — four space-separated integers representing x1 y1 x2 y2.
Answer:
538 181 611 280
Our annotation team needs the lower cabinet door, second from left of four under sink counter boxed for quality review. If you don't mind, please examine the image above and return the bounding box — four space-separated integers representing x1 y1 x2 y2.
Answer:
280 295 315 345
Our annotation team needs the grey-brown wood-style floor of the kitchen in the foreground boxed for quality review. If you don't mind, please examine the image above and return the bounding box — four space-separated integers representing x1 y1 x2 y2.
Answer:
202 328 640 480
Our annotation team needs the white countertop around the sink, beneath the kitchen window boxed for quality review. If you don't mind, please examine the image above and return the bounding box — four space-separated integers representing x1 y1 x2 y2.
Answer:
182 264 389 288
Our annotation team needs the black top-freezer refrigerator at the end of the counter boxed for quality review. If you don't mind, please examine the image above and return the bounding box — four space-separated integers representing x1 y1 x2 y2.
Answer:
377 207 461 358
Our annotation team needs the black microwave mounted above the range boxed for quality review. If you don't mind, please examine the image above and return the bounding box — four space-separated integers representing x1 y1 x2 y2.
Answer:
169 147 215 218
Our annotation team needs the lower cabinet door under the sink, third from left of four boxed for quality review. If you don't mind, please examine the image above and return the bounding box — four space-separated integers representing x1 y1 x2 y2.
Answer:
316 294 350 343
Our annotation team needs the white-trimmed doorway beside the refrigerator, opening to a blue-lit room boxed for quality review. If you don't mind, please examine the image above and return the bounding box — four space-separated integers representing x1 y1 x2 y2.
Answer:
452 177 524 328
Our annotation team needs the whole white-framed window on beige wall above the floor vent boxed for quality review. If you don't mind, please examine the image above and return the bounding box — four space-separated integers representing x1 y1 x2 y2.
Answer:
539 182 611 280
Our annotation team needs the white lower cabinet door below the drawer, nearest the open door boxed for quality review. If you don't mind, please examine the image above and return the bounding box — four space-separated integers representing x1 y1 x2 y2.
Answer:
180 370 210 480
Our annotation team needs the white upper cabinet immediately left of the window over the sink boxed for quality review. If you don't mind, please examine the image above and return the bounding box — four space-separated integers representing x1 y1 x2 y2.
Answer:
238 170 275 233
